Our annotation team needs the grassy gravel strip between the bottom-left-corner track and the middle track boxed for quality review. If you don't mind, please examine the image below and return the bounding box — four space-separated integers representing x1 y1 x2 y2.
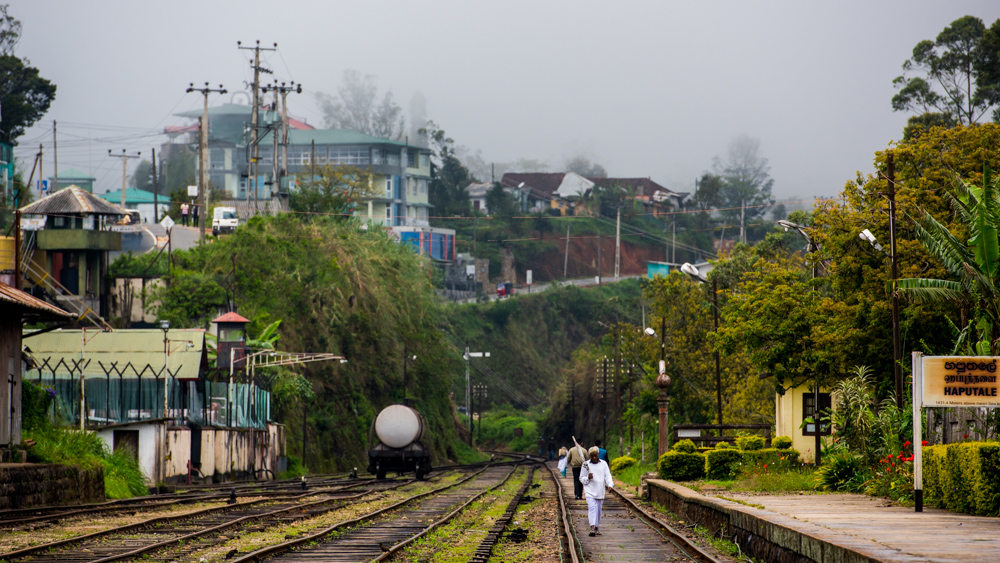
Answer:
188 471 467 562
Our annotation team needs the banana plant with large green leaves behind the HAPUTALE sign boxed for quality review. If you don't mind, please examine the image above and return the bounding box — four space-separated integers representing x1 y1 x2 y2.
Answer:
897 166 1000 355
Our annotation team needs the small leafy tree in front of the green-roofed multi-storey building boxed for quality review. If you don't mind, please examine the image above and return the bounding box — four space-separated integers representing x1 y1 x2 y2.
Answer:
288 164 382 217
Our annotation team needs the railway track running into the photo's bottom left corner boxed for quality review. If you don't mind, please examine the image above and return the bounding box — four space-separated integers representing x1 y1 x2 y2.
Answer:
0 480 412 563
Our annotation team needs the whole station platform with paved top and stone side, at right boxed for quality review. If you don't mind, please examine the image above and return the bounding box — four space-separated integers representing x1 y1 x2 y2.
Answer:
647 479 1000 563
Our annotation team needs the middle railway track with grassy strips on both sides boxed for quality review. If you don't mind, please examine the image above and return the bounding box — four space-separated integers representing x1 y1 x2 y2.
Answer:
233 463 519 563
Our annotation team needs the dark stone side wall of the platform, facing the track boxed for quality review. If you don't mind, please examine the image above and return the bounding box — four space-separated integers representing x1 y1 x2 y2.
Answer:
646 479 877 563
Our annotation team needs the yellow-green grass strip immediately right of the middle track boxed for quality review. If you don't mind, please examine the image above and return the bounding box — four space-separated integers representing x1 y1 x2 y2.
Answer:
393 467 539 563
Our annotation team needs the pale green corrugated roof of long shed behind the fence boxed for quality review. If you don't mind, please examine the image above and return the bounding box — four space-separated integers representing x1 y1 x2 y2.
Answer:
25 328 207 379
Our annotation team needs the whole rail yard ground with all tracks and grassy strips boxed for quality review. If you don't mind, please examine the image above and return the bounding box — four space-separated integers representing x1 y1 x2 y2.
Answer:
0 454 717 563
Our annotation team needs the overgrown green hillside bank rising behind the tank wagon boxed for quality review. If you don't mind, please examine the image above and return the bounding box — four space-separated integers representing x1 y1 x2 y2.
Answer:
159 215 468 471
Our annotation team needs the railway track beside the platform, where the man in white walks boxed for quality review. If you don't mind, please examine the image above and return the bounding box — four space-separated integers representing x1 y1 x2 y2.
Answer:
547 464 719 563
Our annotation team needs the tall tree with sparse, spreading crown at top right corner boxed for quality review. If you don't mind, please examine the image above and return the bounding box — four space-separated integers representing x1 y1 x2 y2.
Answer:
892 16 1000 125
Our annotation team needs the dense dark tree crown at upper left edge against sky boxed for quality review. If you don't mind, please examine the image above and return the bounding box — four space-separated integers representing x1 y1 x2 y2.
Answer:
0 55 56 144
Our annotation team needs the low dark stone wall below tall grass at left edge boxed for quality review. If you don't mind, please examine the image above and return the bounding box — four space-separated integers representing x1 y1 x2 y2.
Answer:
0 463 105 510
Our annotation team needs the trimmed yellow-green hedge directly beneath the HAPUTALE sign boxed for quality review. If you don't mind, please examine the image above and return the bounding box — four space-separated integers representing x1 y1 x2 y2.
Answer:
923 442 1000 516
